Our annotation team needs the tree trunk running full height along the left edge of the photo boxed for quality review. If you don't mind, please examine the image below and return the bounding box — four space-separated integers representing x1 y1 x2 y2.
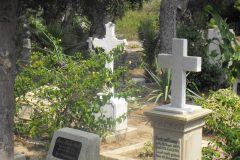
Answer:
0 0 17 160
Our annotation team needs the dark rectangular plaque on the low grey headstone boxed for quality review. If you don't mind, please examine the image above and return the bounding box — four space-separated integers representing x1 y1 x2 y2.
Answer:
53 137 82 160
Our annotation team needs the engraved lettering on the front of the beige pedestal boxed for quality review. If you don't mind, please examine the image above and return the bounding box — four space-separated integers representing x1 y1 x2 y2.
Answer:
155 136 180 160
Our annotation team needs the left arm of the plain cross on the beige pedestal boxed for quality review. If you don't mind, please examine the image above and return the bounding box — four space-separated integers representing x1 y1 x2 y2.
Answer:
158 54 173 68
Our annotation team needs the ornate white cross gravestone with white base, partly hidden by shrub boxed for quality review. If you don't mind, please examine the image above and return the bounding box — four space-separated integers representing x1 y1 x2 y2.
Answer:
87 22 128 131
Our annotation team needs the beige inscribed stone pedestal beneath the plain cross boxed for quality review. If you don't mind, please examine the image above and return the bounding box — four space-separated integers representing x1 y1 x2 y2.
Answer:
145 109 211 160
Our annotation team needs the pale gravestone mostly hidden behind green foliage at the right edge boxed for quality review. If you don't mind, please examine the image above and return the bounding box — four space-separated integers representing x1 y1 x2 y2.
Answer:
208 28 240 95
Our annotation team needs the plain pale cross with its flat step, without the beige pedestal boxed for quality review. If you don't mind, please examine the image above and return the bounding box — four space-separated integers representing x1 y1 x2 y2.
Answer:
156 38 201 113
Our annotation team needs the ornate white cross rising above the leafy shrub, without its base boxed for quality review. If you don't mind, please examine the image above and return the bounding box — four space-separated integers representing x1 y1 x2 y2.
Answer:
88 22 127 71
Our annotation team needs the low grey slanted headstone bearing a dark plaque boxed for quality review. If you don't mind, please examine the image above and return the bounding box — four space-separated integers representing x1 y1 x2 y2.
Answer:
47 128 100 160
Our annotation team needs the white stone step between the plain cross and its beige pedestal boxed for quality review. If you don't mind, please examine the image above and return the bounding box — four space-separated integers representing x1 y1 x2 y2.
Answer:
154 104 202 114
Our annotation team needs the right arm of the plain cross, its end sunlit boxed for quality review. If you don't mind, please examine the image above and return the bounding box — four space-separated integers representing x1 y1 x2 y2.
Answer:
182 56 202 72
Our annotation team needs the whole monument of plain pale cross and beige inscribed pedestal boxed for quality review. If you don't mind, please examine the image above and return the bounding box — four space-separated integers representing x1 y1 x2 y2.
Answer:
145 39 211 160
